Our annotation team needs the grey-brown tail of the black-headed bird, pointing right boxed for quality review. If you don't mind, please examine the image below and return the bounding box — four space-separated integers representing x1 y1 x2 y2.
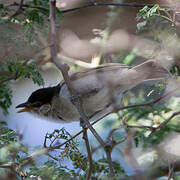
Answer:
133 60 170 81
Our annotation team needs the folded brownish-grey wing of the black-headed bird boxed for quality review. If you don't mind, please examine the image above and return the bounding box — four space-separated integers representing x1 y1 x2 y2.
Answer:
71 63 130 96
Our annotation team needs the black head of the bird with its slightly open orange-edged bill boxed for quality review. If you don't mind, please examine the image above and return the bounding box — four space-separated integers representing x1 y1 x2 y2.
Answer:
16 86 59 112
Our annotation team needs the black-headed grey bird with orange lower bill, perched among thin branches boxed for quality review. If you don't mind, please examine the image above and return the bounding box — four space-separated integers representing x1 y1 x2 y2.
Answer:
16 60 169 122
